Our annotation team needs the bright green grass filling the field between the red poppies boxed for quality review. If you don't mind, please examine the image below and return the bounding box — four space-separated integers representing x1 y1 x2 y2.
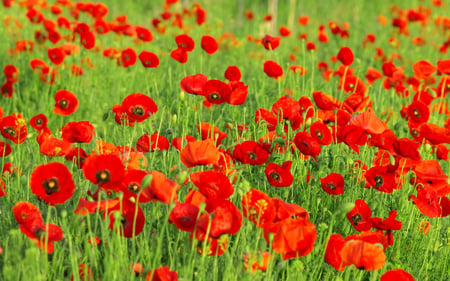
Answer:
0 0 450 281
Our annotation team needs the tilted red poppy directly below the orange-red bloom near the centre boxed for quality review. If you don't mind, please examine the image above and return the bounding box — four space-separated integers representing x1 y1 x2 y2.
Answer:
190 170 234 200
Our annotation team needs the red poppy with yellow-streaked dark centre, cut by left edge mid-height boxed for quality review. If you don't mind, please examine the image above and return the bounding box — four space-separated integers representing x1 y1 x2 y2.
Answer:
0 113 27 144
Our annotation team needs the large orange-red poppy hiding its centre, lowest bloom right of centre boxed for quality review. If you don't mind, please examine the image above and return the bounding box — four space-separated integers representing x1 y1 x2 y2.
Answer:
266 217 317 260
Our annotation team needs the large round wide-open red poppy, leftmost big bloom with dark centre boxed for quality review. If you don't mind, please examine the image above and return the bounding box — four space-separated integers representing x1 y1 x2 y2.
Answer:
30 162 75 205
